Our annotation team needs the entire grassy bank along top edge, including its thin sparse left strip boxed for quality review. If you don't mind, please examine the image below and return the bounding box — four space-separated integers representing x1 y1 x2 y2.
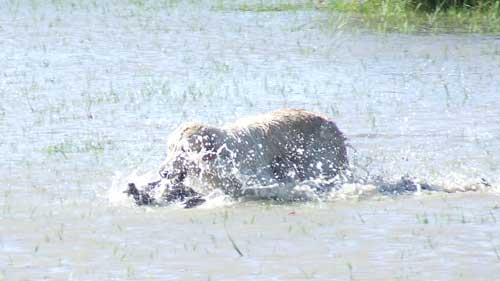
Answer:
215 0 500 33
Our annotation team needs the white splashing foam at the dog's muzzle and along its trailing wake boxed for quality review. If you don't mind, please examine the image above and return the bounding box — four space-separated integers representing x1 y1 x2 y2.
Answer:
105 166 500 209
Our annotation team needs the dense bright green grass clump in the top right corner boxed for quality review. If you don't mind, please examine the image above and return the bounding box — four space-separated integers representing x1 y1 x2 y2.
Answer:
321 0 500 33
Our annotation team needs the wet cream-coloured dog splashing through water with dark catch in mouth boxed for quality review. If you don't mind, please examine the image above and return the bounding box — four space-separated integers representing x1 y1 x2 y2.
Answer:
125 109 348 207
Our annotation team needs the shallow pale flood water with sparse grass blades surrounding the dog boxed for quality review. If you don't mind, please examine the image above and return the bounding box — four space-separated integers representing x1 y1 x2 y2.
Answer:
0 1 500 280
